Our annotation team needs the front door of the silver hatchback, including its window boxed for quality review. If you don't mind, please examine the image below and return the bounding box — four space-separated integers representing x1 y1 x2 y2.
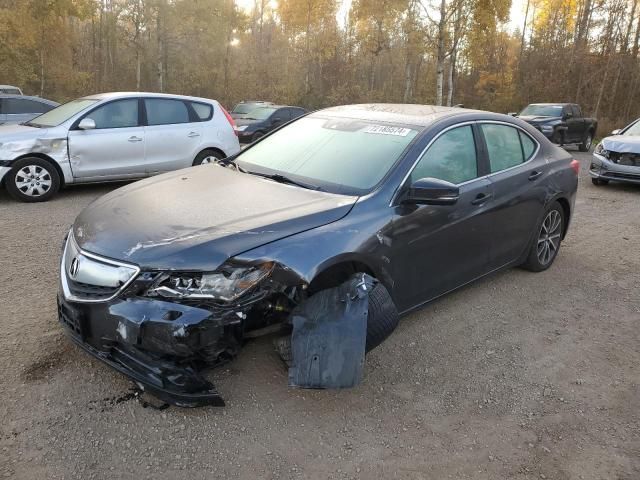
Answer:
68 98 145 182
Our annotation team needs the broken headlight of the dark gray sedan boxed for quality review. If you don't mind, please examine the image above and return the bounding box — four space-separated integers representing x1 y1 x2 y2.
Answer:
147 262 274 302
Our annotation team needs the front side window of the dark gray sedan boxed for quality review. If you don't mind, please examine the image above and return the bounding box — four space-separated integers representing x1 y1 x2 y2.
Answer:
411 126 478 184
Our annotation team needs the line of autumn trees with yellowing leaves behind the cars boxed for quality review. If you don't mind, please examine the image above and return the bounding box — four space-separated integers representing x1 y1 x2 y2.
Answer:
0 0 640 128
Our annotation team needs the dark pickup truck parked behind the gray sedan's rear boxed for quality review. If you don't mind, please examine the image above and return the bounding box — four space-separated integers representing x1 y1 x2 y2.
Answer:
511 103 598 152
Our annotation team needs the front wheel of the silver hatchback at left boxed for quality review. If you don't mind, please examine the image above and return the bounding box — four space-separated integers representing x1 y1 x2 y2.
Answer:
5 157 60 203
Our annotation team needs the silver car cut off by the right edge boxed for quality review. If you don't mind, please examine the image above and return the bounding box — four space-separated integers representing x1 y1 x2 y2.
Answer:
589 119 640 186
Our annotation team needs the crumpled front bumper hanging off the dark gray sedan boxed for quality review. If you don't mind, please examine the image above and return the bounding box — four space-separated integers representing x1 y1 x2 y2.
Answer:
58 294 235 407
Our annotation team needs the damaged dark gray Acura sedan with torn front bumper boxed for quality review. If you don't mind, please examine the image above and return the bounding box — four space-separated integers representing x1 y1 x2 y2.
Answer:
58 105 579 406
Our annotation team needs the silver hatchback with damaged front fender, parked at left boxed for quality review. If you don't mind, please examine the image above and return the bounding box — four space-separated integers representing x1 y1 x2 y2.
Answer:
0 92 240 202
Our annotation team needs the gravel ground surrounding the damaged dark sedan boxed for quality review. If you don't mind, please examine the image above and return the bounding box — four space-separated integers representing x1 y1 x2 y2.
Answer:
0 152 640 480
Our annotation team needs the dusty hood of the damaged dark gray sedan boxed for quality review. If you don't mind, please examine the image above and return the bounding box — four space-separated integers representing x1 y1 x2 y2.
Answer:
73 165 357 271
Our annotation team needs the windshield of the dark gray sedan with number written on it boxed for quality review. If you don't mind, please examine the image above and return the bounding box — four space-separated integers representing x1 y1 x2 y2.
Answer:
237 115 418 195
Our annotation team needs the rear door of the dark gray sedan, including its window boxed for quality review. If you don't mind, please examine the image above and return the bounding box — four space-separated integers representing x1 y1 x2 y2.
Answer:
480 123 548 270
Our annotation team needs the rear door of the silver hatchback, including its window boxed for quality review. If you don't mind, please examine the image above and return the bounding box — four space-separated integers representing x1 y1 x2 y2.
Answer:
143 98 202 174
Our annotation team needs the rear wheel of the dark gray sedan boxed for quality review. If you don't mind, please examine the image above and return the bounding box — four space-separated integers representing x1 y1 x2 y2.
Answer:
522 202 566 272
